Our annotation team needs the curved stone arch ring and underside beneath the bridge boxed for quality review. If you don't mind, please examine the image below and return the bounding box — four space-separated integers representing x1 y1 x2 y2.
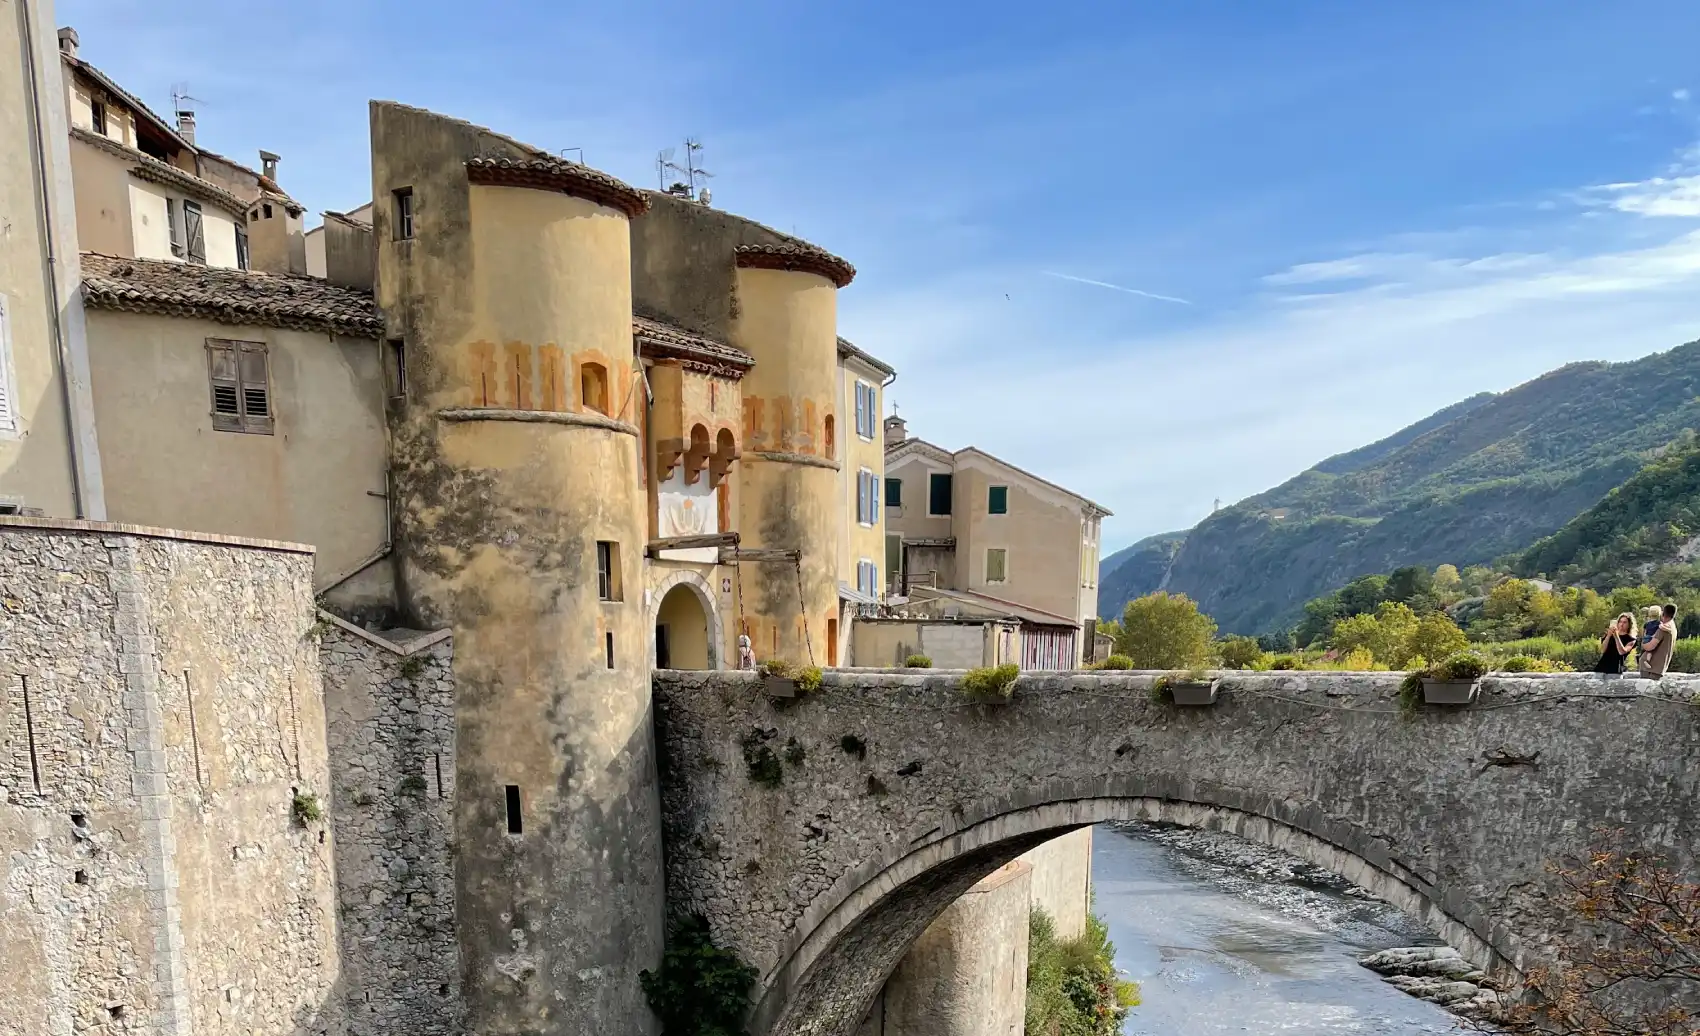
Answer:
751 788 1520 1036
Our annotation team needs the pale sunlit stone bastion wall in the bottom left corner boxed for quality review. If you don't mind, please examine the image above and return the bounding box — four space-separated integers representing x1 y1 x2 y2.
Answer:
0 517 343 1036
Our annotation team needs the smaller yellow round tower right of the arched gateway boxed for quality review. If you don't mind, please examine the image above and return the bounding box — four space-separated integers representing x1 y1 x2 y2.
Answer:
731 243 855 665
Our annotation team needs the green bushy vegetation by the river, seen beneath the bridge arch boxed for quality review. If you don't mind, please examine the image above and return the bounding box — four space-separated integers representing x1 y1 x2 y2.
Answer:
1025 908 1139 1036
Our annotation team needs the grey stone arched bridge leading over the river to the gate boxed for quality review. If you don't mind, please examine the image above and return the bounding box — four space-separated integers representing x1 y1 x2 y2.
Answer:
655 670 1700 1036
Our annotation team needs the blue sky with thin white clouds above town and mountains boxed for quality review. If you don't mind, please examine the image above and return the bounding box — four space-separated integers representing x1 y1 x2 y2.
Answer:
58 0 1700 548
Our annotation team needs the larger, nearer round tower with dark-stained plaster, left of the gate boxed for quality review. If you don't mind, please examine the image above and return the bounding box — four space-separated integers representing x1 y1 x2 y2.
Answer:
372 104 663 1036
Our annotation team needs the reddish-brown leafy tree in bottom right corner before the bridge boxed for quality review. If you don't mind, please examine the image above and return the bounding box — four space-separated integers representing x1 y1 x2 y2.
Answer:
1499 834 1700 1036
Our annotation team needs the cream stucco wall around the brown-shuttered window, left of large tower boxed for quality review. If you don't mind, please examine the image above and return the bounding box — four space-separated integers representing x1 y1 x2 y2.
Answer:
88 304 388 585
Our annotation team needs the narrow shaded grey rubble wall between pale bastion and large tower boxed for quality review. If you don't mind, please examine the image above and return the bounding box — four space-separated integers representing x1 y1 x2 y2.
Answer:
320 612 461 1036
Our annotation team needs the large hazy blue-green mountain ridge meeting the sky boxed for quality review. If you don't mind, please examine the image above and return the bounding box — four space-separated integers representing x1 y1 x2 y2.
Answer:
1100 342 1700 633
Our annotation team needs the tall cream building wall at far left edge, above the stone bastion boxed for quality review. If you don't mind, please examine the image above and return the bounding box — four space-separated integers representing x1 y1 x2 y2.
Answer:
0 3 75 517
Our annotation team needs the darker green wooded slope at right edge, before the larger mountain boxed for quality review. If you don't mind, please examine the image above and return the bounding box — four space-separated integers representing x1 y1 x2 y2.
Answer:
1510 435 1700 589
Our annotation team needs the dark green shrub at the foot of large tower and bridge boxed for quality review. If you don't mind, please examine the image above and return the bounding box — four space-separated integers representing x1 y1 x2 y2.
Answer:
638 915 758 1036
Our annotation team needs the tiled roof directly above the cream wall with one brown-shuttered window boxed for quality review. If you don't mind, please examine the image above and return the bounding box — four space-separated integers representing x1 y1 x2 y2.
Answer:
82 252 384 339
